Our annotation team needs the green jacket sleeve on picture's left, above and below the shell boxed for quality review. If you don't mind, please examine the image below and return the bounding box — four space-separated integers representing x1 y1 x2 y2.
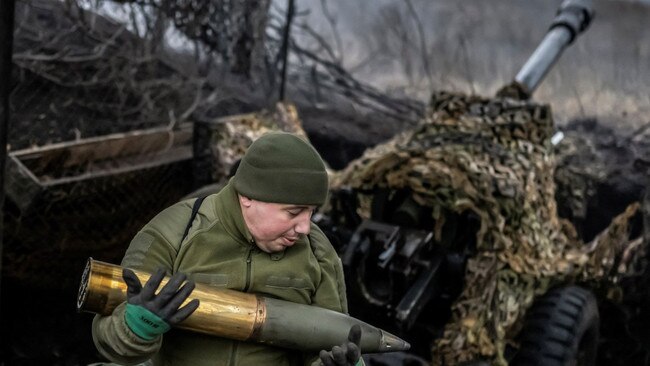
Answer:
92 201 191 365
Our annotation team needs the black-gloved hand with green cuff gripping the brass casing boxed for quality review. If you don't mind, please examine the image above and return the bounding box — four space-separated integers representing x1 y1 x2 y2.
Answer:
122 268 199 340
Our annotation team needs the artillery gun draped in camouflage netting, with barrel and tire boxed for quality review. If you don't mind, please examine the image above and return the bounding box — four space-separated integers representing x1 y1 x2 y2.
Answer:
315 0 638 365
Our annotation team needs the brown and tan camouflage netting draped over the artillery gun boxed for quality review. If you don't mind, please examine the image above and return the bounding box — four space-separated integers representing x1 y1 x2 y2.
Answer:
332 93 641 365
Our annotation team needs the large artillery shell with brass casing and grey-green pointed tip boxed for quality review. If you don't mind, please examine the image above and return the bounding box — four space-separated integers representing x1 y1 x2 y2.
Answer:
77 258 410 353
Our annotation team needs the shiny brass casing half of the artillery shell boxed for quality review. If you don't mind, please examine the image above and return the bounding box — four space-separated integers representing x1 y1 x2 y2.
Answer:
77 258 266 341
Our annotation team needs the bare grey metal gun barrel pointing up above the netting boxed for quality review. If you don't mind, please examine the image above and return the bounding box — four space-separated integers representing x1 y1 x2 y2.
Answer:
502 0 594 99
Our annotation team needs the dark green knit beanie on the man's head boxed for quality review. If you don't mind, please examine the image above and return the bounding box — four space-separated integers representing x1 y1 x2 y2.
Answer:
233 132 328 206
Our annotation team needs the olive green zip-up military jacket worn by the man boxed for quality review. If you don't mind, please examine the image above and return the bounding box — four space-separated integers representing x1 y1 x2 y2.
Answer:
92 184 347 366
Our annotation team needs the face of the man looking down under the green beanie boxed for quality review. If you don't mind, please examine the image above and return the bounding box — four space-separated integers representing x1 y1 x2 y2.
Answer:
239 195 316 253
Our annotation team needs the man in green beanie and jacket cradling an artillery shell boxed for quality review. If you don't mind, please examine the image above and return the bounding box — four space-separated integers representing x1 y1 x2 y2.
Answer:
92 133 363 366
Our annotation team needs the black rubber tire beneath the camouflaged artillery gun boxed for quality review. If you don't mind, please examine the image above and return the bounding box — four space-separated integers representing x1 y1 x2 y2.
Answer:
510 286 600 366
